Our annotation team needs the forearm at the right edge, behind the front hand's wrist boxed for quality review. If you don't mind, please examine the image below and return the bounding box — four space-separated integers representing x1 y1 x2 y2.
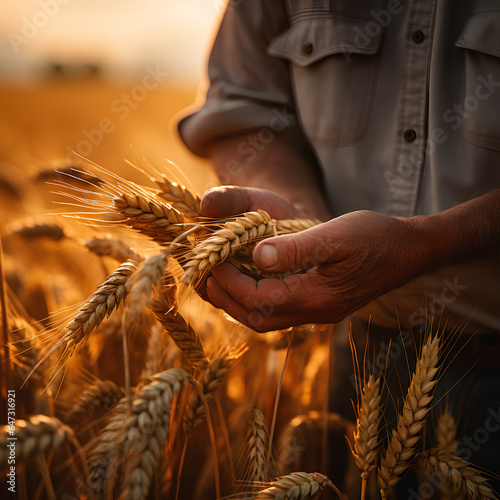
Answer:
409 190 500 272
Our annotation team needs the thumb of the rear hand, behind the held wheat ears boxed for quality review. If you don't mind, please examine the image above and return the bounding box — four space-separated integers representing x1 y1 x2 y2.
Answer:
201 186 251 218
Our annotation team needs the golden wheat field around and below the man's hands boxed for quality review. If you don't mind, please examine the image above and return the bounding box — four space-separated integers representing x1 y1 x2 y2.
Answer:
0 81 497 500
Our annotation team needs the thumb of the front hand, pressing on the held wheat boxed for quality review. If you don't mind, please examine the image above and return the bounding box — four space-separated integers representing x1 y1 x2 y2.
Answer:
253 224 333 273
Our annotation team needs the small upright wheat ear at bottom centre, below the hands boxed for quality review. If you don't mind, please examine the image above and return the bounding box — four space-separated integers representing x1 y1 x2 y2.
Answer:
247 408 270 481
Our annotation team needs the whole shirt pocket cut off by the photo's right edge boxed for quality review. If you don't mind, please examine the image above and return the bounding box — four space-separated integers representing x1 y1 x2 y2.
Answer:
455 11 500 151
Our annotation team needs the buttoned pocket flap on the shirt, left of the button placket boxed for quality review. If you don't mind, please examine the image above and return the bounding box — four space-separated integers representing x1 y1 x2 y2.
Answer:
267 17 383 66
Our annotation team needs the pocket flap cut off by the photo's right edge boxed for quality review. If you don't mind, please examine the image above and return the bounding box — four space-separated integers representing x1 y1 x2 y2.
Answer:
455 11 500 57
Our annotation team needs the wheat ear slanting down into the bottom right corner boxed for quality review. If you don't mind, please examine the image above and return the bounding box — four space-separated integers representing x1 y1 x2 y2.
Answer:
420 448 498 500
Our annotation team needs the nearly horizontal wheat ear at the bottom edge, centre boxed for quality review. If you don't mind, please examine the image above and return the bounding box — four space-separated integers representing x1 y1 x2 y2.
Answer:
255 472 330 500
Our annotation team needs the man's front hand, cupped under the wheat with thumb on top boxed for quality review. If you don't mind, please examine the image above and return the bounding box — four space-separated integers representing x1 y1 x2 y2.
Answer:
207 211 429 332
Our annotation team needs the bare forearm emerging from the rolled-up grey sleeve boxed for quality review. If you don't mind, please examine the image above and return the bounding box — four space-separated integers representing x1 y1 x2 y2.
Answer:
210 134 331 220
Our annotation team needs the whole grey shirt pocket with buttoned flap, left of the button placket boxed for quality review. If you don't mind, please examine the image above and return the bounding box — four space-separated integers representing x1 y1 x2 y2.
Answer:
267 17 383 147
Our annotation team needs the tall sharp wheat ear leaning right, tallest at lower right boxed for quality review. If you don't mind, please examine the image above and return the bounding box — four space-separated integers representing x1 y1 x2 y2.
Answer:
377 334 439 499
